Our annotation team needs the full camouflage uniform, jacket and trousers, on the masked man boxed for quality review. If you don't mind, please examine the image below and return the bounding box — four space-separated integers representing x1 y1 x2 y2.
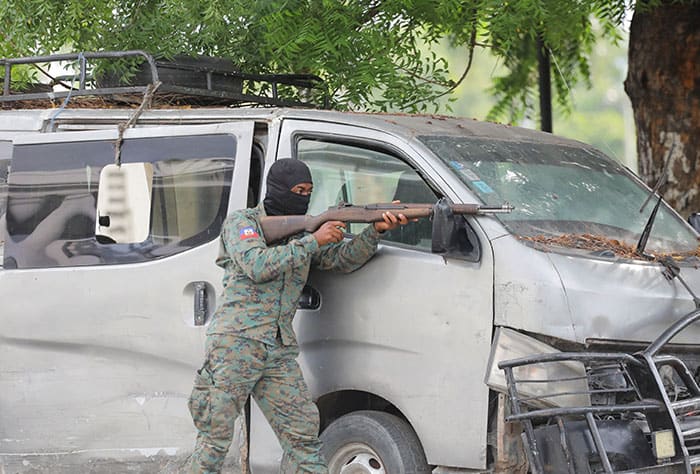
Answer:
189 204 379 473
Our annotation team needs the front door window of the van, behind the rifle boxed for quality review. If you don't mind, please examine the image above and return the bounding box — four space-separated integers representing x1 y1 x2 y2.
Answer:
296 139 438 250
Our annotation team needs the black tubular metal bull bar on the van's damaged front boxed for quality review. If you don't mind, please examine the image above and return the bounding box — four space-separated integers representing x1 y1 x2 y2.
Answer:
499 310 700 473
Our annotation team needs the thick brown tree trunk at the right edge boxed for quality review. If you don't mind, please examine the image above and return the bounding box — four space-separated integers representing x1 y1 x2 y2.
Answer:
625 1 700 217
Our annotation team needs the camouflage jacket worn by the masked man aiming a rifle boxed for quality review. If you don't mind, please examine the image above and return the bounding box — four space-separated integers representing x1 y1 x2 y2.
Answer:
207 203 379 345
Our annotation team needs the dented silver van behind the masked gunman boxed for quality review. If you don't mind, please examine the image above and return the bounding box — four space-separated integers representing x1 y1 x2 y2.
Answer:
0 52 700 474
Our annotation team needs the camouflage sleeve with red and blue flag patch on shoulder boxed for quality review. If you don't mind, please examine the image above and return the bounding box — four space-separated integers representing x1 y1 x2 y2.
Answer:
221 211 318 283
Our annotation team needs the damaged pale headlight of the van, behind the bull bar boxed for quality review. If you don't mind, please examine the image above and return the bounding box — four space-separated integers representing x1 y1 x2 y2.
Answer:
486 327 591 408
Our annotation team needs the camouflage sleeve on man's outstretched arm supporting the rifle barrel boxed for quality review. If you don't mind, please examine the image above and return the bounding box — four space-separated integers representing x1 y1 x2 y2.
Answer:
311 225 380 273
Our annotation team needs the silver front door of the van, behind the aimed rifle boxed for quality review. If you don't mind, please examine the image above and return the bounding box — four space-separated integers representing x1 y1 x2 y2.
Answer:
251 120 493 468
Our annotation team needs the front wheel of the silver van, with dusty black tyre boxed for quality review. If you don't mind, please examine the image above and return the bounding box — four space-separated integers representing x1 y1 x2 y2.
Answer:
321 411 431 474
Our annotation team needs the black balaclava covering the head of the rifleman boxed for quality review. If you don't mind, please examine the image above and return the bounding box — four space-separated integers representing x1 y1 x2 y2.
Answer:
263 159 313 216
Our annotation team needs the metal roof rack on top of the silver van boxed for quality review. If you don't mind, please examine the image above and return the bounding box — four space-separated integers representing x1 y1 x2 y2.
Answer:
0 50 328 108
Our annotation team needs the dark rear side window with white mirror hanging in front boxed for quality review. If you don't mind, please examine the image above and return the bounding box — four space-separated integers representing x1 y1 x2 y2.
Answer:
4 135 236 268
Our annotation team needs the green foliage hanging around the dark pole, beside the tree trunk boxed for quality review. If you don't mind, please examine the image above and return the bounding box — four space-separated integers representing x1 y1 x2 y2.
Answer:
488 0 625 121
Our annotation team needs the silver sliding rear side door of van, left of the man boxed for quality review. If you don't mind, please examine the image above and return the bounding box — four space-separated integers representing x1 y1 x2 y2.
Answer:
0 122 253 472
